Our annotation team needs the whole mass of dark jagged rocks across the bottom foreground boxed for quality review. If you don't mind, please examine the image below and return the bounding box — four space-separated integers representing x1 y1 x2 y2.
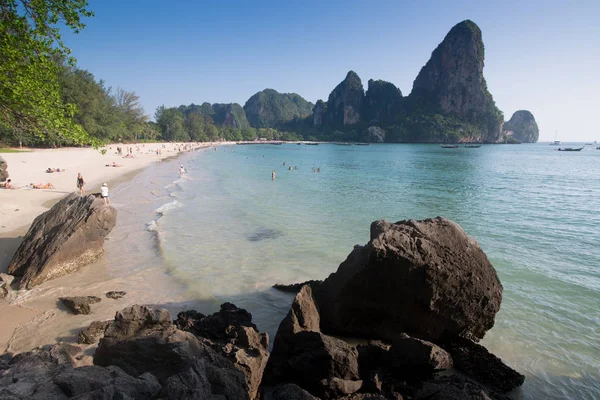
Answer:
0 217 524 400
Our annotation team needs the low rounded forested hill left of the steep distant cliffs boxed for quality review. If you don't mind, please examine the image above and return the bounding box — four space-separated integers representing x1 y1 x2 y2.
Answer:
244 89 313 128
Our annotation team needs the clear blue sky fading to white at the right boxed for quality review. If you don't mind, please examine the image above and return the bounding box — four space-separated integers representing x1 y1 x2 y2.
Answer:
63 0 600 142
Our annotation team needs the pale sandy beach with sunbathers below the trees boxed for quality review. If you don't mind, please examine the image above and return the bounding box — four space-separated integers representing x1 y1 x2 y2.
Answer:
0 142 228 354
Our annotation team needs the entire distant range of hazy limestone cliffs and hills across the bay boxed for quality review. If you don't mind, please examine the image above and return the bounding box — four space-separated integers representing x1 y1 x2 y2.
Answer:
168 20 539 143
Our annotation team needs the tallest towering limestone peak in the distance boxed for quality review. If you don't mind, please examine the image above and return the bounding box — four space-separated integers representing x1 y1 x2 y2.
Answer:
410 20 503 142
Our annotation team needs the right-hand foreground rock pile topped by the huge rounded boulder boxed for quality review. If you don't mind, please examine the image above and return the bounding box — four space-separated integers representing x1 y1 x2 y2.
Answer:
264 217 524 399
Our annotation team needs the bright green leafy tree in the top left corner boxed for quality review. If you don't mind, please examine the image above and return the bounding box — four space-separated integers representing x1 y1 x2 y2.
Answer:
0 0 93 143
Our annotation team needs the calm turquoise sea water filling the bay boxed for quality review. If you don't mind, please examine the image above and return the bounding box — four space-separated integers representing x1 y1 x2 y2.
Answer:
116 144 600 399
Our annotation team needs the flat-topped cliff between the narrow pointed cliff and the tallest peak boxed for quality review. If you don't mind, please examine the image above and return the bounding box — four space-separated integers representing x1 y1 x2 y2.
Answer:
363 79 402 122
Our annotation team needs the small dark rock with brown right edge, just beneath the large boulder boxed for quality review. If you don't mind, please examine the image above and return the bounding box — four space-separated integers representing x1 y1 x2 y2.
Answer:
387 335 452 377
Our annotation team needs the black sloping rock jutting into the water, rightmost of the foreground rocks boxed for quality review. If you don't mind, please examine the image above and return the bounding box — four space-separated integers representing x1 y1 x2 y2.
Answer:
446 339 525 393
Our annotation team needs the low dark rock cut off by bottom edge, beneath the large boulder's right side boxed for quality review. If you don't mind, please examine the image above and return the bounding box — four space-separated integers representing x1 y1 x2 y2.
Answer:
411 375 509 400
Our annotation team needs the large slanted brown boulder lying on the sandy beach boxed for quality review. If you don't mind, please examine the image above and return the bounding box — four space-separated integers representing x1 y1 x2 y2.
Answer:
8 193 117 289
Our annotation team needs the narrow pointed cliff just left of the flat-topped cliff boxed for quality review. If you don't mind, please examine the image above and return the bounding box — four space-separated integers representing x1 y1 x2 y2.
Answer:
324 71 365 126
